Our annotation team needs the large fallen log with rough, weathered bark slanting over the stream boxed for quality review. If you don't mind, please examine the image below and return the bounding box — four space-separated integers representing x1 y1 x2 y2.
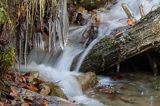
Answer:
80 8 160 71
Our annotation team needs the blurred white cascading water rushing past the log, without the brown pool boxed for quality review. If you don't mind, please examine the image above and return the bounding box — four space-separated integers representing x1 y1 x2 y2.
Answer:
18 0 159 106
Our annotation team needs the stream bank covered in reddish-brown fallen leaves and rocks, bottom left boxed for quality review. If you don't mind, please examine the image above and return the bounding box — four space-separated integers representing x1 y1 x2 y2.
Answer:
0 71 75 106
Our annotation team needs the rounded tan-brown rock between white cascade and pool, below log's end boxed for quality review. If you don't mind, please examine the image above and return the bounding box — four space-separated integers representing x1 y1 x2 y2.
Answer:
76 72 97 91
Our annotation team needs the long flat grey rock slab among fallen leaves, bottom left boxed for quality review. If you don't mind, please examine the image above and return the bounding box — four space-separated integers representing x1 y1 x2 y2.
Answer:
12 87 76 106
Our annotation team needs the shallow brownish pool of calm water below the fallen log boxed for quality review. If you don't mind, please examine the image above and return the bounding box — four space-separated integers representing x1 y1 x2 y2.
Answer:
86 73 160 106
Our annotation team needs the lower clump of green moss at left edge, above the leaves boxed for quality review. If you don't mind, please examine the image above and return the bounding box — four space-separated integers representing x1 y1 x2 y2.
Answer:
0 47 14 71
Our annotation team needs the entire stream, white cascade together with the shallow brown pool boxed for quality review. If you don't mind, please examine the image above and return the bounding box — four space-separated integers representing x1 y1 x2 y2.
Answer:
17 0 160 106
